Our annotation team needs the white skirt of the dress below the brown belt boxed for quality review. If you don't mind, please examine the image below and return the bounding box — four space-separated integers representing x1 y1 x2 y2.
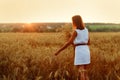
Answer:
74 45 90 65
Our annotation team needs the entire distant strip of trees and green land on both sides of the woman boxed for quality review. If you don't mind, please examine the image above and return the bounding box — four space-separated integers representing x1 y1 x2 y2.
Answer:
0 23 120 32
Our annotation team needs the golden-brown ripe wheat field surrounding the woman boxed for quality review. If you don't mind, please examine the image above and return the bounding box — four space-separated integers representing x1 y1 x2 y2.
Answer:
0 32 120 80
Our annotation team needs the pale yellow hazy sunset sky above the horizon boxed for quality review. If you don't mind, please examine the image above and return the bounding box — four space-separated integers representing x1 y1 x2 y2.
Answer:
0 0 120 23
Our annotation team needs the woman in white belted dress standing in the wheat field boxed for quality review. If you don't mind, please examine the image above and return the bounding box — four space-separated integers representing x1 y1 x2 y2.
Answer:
55 15 90 80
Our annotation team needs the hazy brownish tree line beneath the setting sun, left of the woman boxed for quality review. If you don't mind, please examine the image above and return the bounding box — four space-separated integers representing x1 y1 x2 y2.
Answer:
0 23 66 32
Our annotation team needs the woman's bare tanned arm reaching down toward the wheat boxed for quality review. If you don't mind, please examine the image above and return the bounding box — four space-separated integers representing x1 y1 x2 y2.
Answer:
55 31 77 55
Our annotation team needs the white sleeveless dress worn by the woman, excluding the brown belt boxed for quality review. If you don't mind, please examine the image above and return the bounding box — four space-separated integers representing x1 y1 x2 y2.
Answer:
74 28 90 65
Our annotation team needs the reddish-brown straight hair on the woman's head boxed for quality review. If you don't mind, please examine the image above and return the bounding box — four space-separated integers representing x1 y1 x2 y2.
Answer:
72 15 85 29
